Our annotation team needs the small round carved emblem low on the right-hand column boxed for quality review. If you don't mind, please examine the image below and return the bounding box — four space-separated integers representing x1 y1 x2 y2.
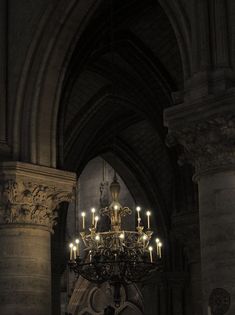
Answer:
209 288 231 315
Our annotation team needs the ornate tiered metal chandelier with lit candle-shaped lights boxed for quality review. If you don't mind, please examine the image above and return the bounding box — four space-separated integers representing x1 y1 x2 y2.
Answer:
69 174 162 306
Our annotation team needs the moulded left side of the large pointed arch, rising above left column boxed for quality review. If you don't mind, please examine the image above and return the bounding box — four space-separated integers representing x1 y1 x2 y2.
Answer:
10 0 188 167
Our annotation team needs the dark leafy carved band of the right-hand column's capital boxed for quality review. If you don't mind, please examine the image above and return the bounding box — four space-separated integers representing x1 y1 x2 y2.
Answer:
167 114 235 179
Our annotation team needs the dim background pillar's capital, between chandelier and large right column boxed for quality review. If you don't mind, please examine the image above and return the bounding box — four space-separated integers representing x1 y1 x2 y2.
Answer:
172 212 200 263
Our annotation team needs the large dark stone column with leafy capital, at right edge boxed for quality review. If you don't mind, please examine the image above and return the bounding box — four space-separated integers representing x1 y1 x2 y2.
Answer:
165 104 235 315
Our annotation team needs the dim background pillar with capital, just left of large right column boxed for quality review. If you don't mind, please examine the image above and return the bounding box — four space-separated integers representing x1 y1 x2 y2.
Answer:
172 211 202 315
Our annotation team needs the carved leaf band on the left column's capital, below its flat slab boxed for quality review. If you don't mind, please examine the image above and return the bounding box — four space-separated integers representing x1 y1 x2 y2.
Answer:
0 180 73 229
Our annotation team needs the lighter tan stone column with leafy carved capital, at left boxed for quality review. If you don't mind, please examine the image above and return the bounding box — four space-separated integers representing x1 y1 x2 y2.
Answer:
0 162 75 315
